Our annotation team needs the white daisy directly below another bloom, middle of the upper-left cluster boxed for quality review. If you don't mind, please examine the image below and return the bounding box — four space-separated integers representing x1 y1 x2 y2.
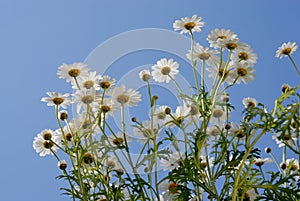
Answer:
74 88 101 113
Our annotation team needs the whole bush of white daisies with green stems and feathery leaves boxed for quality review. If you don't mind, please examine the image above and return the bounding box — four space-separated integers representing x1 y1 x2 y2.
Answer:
33 15 300 201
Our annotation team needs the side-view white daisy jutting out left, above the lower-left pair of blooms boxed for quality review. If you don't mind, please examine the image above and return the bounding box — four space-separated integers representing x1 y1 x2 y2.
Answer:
41 92 72 109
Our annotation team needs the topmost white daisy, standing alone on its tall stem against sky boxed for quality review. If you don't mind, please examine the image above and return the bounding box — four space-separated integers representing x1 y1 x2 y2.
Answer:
173 15 205 34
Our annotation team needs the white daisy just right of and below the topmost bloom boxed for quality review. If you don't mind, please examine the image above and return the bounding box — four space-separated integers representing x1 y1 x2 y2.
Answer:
207 29 239 49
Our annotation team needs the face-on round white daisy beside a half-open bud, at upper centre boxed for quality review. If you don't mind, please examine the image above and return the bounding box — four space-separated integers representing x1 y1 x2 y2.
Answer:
152 58 179 83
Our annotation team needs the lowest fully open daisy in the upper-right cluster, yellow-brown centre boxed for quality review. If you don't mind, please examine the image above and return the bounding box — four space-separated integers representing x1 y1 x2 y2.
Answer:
231 62 255 84
